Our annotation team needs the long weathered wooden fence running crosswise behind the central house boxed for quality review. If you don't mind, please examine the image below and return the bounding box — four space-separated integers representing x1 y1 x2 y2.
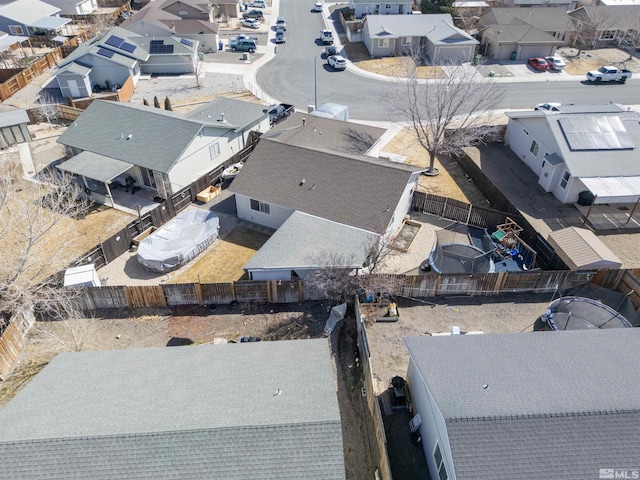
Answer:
75 270 640 310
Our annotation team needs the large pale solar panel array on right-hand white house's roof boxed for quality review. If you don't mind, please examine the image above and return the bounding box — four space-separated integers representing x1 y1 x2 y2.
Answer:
558 116 634 151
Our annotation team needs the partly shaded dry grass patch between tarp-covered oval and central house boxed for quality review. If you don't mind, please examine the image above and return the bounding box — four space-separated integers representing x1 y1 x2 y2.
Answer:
170 227 269 283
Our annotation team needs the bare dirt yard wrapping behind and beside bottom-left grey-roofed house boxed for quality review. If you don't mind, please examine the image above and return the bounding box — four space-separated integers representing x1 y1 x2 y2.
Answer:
0 302 374 480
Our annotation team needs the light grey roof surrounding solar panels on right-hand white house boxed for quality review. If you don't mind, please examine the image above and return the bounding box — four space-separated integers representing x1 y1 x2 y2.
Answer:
506 109 640 178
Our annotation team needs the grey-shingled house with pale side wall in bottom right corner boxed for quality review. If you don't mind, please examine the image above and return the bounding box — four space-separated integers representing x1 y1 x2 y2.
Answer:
404 328 640 480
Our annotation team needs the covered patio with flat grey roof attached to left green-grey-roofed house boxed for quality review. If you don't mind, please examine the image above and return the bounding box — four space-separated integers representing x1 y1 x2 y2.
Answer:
57 152 158 215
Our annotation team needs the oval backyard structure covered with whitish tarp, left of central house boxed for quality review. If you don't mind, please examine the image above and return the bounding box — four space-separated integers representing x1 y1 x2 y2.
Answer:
138 208 220 273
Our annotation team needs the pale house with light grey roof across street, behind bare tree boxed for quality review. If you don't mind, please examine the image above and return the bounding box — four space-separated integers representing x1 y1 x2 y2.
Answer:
363 14 479 64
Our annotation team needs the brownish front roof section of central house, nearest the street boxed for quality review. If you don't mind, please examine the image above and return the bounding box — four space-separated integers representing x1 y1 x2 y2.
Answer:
263 112 385 155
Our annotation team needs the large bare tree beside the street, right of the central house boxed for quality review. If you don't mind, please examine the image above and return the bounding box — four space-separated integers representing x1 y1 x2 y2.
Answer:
382 58 501 172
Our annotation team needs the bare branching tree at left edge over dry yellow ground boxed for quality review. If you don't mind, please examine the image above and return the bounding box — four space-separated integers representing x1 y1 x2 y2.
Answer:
0 156 88 328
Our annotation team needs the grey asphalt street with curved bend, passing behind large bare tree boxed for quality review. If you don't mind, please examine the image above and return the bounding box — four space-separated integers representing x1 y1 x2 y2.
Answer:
256 0 640 121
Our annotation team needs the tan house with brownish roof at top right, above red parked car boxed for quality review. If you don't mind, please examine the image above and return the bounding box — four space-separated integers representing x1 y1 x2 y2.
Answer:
478 7 576 61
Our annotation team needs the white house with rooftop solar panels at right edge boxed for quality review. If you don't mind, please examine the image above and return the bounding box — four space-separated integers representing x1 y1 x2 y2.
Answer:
504 104 640 204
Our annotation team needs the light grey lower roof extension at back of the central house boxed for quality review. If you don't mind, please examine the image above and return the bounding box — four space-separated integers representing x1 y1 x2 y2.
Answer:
243 212 379 270
